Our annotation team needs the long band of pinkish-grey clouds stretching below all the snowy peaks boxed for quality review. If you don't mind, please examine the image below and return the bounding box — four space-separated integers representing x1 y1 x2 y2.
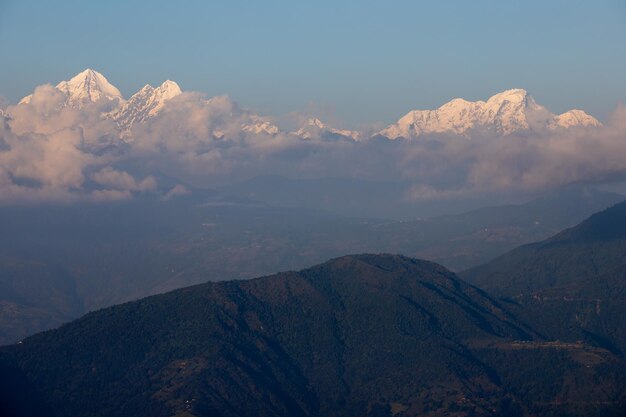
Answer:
0 79 626 203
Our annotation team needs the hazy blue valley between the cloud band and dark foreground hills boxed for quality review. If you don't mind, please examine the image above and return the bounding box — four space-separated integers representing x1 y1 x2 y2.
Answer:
0 185 622 343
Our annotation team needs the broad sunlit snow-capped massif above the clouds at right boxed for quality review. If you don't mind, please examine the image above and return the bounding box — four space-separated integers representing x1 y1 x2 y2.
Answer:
380 89 600 139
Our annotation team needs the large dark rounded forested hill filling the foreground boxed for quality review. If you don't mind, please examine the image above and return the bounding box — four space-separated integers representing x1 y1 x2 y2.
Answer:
0 255 626 417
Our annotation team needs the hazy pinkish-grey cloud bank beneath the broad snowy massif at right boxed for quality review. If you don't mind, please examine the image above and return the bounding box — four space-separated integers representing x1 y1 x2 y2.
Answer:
402 107 626 198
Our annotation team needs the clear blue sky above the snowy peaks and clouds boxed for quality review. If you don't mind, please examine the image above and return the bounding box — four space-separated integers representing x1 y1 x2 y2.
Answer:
0 0 626 127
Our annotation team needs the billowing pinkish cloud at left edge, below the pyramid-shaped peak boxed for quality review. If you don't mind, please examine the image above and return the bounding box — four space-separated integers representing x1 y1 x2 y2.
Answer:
0 85 156 203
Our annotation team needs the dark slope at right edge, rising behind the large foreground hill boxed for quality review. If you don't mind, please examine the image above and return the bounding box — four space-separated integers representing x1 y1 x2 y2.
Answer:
463 202 626 354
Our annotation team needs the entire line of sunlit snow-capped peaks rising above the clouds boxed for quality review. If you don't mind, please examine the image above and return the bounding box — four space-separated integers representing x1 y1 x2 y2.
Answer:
12 69 600 140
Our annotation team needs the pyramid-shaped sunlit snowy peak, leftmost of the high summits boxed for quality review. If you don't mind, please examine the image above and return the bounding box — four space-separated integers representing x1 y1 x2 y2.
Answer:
20 68 124 108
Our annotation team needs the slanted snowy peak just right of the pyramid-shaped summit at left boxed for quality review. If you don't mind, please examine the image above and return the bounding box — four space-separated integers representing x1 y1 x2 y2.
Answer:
113 80 182 131
